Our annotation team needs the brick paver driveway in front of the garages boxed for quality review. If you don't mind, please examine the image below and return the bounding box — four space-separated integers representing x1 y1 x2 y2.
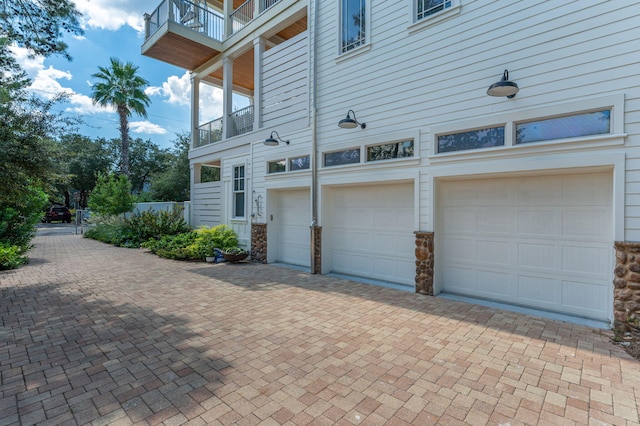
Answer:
0 225 640 426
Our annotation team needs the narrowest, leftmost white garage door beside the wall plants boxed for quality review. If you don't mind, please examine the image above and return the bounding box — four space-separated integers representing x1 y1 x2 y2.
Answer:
274 189 311 267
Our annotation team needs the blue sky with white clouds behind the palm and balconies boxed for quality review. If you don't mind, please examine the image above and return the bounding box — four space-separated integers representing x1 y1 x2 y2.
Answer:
14 0 242 148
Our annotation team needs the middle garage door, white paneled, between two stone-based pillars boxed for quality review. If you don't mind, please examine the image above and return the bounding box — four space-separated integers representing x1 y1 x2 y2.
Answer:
329 184 416 286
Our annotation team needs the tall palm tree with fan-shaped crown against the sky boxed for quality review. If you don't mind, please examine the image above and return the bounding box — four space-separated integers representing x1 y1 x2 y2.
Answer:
92 58 151 177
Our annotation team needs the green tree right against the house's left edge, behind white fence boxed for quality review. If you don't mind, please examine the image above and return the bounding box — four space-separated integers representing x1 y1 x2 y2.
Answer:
150 133 191 201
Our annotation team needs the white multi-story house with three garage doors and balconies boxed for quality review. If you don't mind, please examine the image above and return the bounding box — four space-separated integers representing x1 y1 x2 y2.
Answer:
142 0 640 324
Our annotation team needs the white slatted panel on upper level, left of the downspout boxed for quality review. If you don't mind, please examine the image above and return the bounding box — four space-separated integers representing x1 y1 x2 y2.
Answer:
262 32 309 127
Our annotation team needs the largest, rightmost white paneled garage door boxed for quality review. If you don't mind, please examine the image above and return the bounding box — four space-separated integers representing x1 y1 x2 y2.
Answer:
436 173 613 319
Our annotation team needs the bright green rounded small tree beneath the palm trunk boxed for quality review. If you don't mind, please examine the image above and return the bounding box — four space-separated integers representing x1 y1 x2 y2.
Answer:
89 173 133 216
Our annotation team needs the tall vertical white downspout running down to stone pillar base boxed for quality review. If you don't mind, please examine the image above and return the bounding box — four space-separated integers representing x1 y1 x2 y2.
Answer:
310 0 319 274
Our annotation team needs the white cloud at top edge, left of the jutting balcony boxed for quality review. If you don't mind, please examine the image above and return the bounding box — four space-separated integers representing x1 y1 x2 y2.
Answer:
75 0 145 31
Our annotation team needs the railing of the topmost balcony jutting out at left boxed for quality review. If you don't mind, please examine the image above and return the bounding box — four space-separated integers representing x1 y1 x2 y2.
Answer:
145 0 224 41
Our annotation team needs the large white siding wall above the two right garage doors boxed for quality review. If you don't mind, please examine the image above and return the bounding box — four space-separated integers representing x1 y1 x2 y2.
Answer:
318 0 640 240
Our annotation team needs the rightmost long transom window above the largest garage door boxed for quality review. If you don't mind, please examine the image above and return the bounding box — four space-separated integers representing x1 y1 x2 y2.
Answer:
516 109 611 144
